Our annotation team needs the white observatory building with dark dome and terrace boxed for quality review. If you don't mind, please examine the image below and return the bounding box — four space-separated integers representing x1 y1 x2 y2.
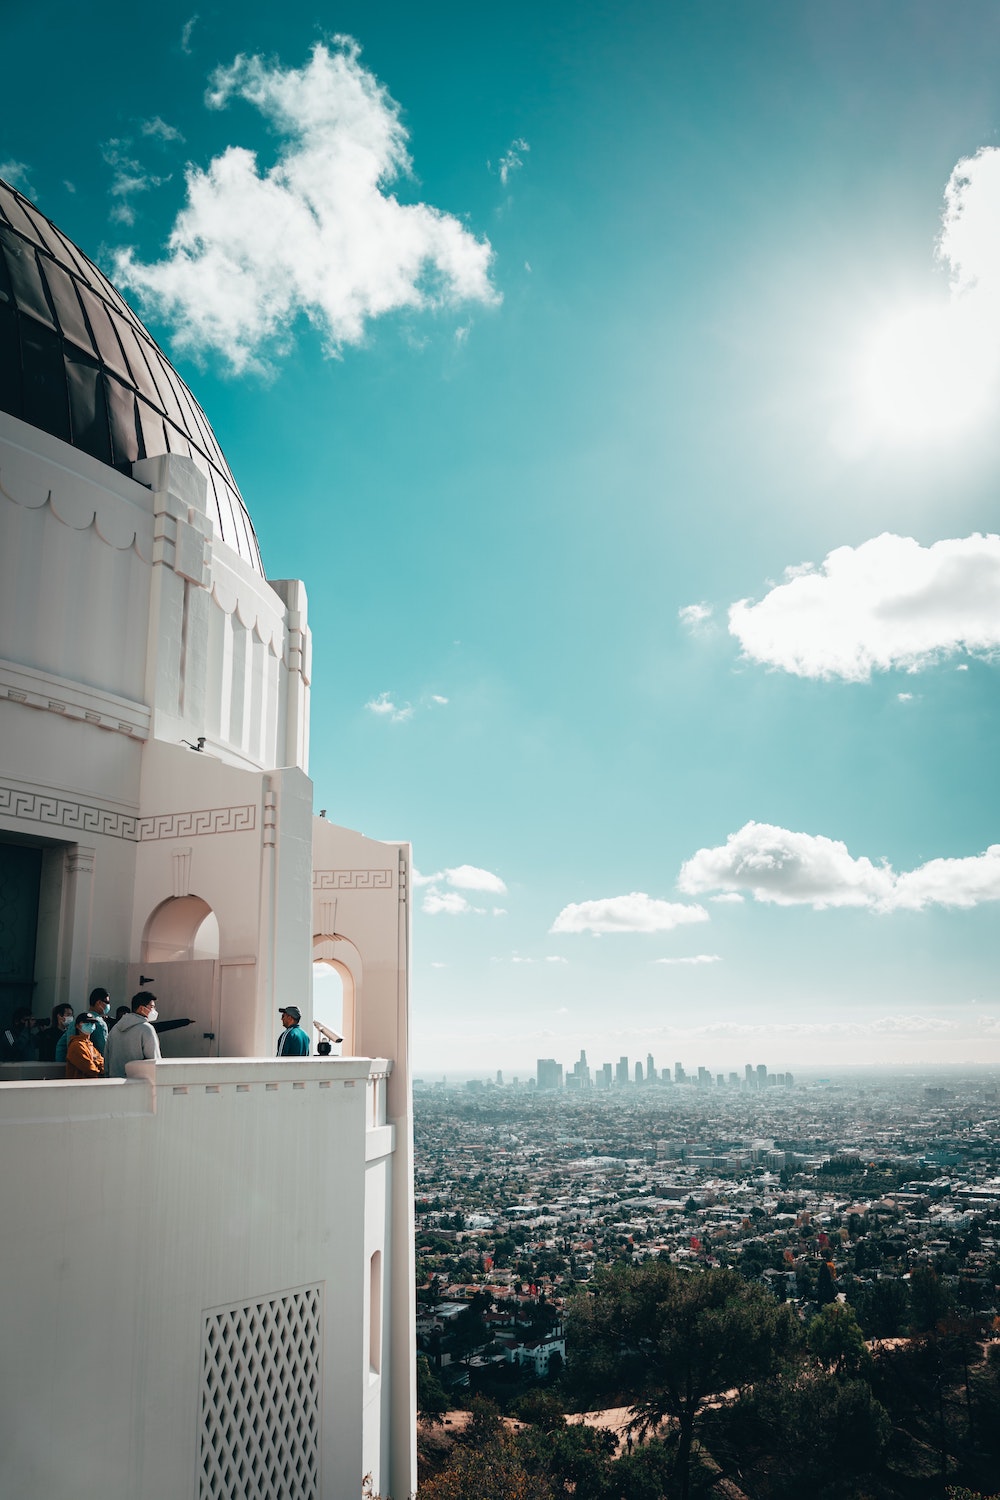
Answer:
0 183 417 1500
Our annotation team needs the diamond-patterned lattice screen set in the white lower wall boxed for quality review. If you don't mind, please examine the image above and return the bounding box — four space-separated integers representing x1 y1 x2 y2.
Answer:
196 1286 322 1500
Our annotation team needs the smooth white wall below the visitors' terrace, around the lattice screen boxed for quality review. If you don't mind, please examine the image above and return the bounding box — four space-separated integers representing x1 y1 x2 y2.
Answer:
0 1059 393 1500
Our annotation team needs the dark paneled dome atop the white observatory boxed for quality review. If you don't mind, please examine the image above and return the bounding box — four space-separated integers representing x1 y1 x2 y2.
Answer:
0 179 264 575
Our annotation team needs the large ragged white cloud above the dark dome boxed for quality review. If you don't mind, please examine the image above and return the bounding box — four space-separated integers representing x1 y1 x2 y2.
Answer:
115 38 499 372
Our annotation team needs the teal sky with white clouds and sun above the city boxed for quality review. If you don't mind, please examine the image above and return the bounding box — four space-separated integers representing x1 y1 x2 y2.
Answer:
7 0 1000 1079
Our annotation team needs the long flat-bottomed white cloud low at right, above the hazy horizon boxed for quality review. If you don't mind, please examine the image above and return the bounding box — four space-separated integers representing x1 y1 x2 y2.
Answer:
678 822 1000 912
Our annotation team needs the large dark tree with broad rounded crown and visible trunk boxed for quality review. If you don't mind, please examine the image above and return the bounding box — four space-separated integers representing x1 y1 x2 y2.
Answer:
568 1260 801 1500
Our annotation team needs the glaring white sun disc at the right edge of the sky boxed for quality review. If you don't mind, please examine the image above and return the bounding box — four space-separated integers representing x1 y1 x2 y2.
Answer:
859 303 996 441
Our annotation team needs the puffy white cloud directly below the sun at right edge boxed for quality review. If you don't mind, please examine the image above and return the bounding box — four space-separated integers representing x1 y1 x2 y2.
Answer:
729 533 1000 683
